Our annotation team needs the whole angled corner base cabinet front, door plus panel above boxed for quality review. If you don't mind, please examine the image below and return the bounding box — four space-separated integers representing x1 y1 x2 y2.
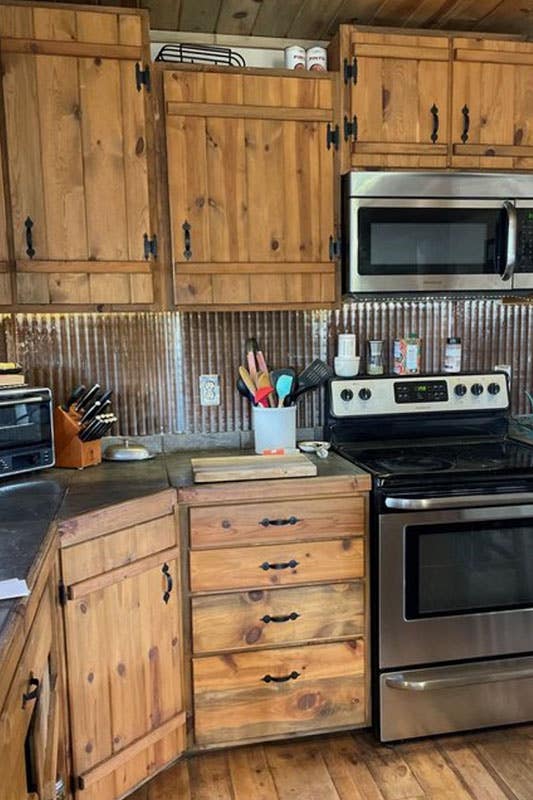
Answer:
61 490 185 800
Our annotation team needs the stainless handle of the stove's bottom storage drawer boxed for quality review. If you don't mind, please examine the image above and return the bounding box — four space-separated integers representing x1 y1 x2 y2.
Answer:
385 666 533 692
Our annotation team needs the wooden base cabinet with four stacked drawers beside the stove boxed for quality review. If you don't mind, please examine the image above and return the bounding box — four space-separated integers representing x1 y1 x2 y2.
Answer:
182 477 369 748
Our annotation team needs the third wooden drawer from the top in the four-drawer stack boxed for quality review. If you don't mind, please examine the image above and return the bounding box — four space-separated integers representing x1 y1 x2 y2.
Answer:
192 581 365 654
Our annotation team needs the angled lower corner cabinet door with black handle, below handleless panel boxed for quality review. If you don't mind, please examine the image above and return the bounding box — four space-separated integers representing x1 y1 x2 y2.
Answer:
65 549 184 800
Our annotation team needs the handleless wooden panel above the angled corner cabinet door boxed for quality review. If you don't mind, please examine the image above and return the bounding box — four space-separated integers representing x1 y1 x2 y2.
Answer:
61 514 176 585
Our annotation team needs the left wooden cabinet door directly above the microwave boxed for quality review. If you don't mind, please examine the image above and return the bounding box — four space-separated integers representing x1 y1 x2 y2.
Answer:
351 31 449 167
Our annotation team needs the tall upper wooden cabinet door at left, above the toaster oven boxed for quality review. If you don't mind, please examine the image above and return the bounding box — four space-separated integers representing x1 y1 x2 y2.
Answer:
0 6 154 306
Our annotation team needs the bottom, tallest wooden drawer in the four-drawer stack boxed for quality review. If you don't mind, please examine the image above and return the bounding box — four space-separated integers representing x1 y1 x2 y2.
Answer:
193 639 366 745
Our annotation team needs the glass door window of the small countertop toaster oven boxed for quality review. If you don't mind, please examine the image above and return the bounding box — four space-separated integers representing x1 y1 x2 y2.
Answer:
0 396 50 449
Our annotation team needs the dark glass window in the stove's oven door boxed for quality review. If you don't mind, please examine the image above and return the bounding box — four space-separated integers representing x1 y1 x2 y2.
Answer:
405 519 533 619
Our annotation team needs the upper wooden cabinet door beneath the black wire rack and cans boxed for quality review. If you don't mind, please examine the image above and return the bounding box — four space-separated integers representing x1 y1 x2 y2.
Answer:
164 71 336 308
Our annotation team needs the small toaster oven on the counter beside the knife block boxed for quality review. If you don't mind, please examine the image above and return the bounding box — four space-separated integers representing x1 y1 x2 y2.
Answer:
0 387 54 477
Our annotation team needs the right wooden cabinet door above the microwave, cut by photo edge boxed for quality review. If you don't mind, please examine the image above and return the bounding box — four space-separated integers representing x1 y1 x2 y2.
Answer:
452 39 533 169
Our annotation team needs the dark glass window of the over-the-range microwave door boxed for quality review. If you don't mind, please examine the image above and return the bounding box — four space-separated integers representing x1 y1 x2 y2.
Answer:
357 204 500 276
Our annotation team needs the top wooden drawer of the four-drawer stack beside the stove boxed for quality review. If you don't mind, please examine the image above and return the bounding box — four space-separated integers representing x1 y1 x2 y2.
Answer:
190 495 365 549
